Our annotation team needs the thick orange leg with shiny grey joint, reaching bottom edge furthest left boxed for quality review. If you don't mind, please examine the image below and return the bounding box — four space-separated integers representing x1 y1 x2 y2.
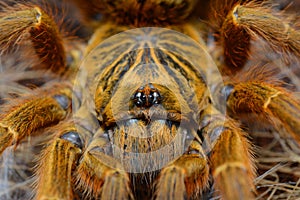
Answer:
36 123 83 200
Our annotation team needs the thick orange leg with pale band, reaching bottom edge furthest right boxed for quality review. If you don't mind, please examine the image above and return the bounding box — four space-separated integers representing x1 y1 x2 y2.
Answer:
211 124 255 199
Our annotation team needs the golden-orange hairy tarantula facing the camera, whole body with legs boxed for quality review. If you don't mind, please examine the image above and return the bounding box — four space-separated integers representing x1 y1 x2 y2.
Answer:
0 0 300 199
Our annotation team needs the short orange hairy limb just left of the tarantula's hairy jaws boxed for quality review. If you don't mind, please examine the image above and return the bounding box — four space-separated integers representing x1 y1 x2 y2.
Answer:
76 129 133 200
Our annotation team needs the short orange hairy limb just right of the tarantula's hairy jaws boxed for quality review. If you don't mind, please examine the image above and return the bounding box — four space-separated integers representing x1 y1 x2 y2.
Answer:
155 140 209 199
